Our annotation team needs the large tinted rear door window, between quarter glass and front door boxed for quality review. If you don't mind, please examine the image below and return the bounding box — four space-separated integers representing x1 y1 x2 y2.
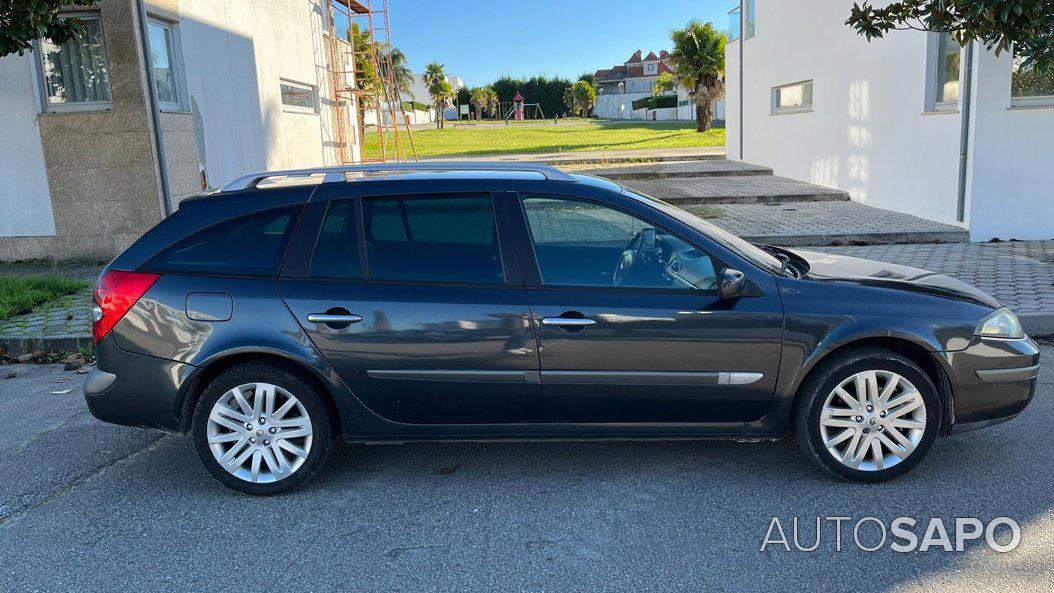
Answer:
363 194 505 284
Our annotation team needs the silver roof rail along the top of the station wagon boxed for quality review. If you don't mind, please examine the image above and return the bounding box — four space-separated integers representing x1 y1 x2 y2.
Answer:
220 161 575 192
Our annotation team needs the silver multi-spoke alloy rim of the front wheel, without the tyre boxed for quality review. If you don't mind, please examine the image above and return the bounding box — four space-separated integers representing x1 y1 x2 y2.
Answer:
820 371 926 472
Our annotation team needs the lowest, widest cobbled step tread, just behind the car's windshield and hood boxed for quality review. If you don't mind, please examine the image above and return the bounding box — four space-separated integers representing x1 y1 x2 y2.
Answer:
684 201 970 246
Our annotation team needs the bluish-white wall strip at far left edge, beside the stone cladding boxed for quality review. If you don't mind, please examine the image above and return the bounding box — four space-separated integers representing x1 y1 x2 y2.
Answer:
0 54 55 237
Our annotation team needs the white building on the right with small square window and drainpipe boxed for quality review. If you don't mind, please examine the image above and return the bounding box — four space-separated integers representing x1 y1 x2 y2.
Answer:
726 0 1054 240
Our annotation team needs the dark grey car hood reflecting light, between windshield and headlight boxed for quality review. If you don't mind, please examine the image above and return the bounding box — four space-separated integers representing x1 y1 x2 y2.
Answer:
794 250 1001 309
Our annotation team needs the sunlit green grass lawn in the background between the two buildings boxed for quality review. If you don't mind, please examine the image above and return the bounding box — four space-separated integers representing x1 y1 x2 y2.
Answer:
365 121 725 158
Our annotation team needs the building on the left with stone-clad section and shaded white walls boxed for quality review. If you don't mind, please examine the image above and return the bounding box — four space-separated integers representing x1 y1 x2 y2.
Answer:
0 0 359 260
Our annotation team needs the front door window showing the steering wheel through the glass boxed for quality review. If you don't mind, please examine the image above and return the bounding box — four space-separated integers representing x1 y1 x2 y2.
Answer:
523 196 717 291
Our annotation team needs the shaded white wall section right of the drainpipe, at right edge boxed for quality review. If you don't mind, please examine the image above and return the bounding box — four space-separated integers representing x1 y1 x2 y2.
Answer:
967 46 1054 241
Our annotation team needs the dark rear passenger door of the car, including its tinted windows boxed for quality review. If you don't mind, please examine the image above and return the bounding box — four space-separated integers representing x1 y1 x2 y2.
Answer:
280 182 541 423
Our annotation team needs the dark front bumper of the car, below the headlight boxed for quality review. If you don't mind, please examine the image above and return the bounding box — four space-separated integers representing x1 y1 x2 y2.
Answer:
941 337 1039 433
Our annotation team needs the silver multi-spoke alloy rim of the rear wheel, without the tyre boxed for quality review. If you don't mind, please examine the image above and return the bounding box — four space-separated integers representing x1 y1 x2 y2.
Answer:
206 382 313 483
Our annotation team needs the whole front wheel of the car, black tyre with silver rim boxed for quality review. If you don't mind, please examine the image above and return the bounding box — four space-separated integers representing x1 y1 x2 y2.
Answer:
794 349 941 482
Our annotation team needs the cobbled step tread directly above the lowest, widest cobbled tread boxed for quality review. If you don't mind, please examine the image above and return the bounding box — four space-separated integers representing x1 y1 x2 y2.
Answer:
619 175 850 203
